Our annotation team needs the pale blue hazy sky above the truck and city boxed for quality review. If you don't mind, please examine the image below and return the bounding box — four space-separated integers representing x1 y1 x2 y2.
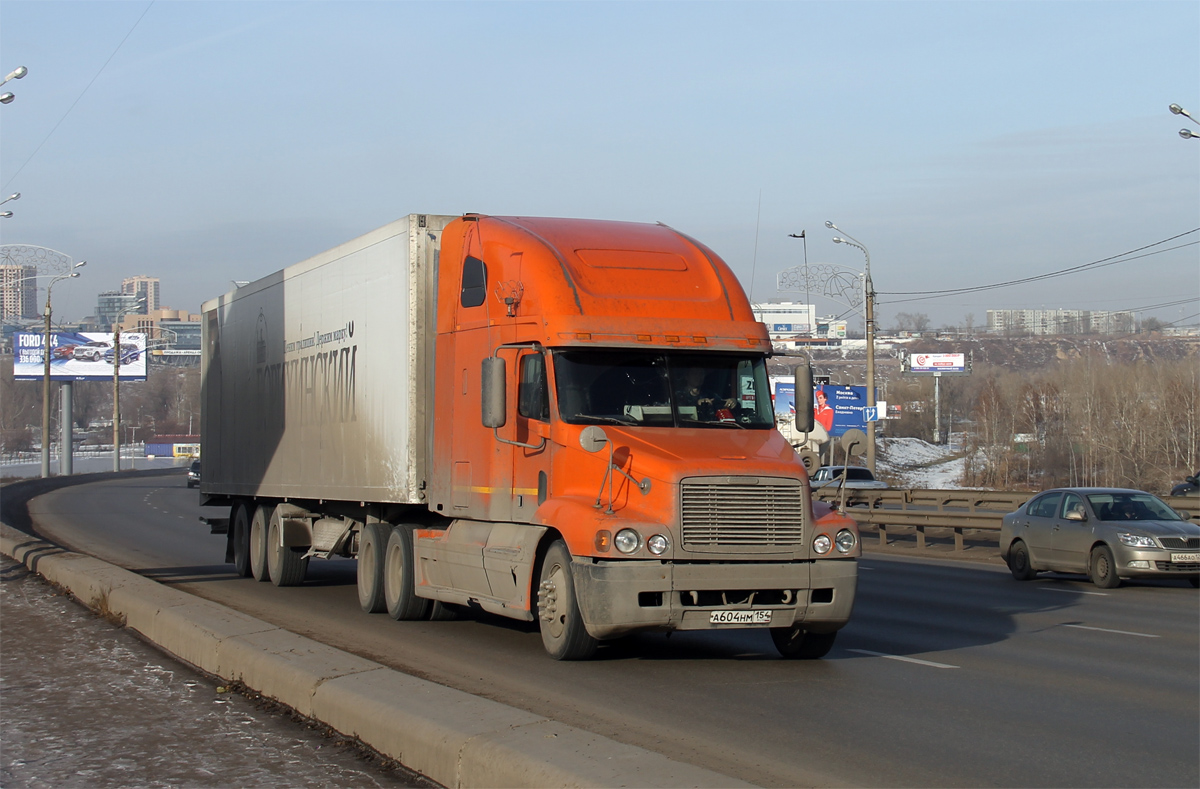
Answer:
0 0 1200 326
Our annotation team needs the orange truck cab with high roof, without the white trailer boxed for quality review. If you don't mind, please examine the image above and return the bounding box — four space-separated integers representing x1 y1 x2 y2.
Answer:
414 217 860 657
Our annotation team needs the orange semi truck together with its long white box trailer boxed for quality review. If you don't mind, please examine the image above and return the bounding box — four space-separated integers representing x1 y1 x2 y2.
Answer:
199 215 860 659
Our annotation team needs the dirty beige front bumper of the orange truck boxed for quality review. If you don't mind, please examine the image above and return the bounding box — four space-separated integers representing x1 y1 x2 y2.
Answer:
571 559 858 639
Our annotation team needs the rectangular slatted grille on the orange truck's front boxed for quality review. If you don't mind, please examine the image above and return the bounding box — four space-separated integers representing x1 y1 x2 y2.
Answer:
680 477 804 548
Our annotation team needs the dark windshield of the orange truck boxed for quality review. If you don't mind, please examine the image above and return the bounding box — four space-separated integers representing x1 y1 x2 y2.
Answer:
554 350 775 429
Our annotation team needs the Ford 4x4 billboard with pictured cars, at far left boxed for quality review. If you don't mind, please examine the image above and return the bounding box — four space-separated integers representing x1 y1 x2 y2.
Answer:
12 331 146 381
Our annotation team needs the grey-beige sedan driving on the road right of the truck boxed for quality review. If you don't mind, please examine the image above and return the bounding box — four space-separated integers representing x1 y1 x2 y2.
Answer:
1000 488 1200 589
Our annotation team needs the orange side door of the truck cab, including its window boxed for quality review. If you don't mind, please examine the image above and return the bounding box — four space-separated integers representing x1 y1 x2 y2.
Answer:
512 349 551 523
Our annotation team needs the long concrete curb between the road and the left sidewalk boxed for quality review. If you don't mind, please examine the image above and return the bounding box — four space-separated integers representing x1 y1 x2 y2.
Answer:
0 515 751 788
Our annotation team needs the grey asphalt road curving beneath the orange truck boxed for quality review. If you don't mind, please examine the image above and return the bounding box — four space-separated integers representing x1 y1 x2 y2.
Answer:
21 475 1200 787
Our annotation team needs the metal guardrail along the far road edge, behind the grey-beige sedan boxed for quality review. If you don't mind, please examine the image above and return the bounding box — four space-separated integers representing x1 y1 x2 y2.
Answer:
812 487 1200 552
